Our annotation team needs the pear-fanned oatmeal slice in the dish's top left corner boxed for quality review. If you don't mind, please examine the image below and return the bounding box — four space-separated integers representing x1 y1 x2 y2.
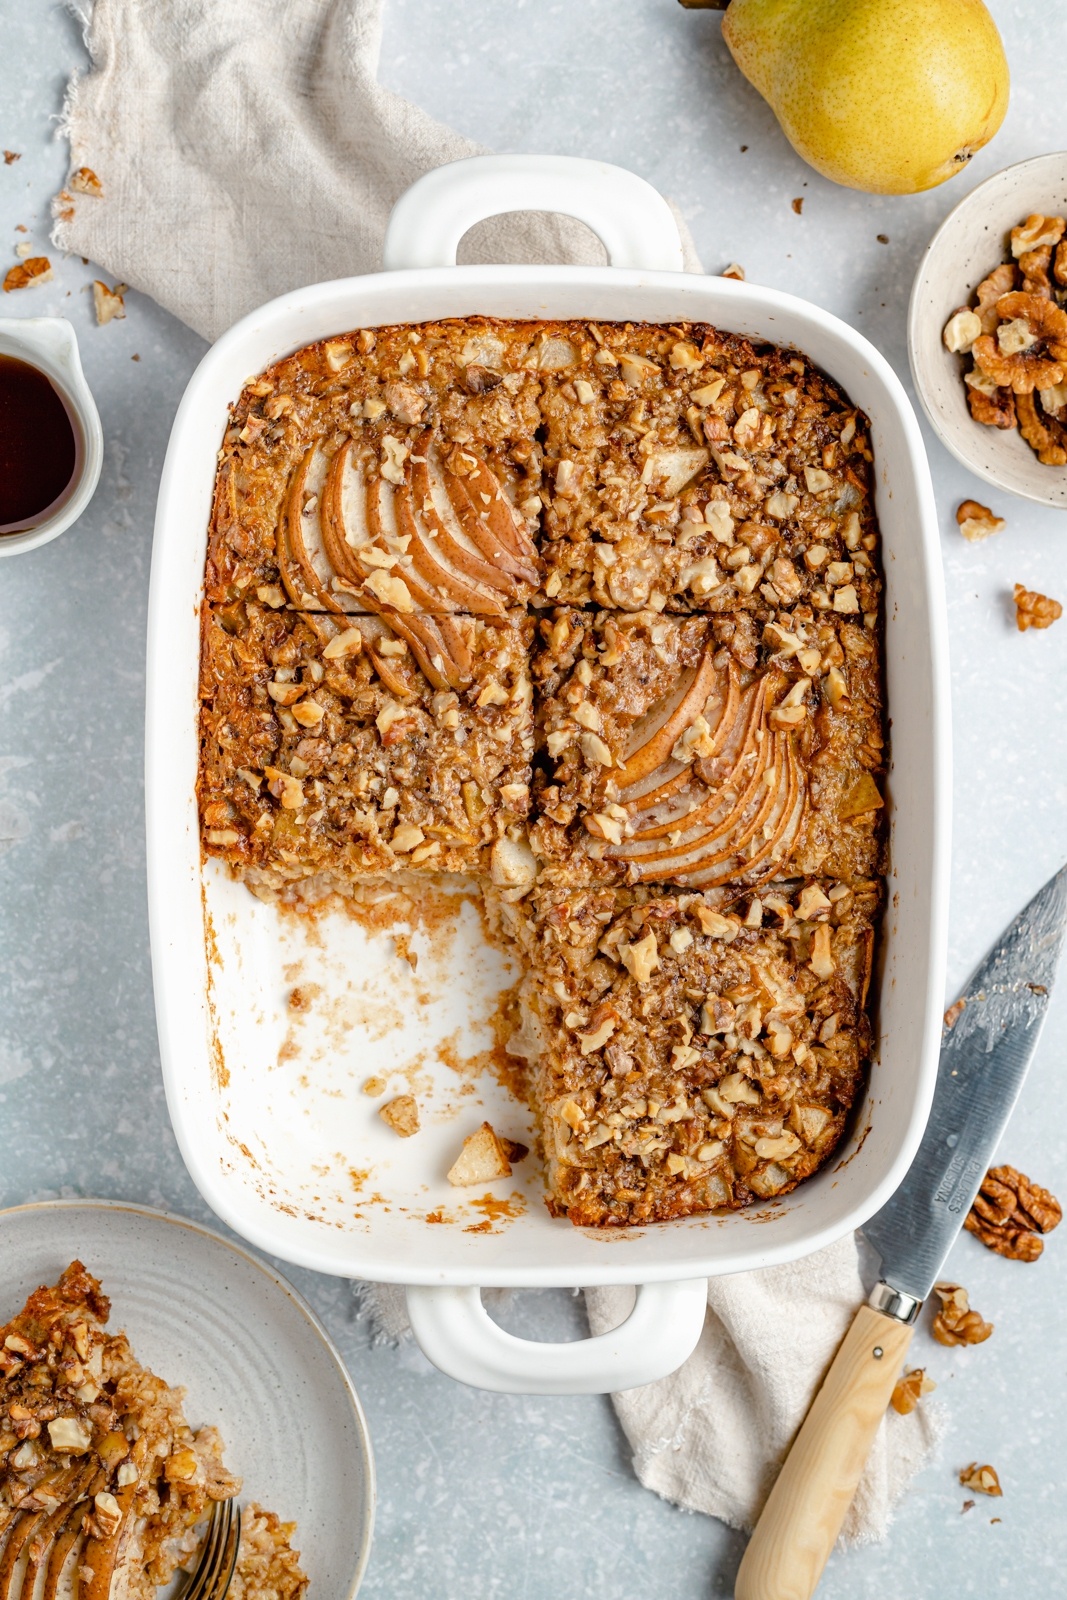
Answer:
206 318 541 618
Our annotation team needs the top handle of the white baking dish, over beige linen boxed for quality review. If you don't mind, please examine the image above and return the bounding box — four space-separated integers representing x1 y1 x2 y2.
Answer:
384 155 683 272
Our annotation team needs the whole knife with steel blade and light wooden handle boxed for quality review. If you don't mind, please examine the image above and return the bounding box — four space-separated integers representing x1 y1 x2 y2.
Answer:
734 867 1067 1600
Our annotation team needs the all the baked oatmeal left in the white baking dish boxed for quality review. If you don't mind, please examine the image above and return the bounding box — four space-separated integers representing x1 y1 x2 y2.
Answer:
200 317 886 1226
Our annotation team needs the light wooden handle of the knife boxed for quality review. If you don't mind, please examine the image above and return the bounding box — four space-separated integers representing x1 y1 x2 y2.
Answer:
734 1306 912 1600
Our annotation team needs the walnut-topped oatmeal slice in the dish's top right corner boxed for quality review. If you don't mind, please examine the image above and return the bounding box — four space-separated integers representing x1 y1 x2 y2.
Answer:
541 323 880 616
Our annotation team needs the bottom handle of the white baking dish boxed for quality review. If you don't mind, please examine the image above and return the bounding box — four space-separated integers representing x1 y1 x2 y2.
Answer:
408 1278 707 1395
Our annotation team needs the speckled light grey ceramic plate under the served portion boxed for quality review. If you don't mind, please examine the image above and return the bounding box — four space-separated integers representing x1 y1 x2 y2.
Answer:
0 1200 374 1600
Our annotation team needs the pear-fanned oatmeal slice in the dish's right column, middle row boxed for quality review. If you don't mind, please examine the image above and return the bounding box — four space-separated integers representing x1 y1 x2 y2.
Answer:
533 606 885 896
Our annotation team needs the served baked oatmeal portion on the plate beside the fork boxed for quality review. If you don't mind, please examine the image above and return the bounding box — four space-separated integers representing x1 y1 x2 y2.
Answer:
0 1261 307 1600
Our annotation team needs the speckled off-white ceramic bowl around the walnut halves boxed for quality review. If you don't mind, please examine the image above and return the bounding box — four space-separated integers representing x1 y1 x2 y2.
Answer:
907 150 1067 510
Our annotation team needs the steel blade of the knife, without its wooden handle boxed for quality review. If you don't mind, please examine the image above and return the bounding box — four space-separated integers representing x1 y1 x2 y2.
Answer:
862 867 1067 1322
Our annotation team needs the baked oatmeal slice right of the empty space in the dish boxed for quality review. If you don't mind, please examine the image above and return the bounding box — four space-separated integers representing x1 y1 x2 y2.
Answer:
490 878 880 1227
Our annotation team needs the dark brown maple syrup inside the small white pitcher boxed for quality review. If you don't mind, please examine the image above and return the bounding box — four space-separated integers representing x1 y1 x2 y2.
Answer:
0 355 78 536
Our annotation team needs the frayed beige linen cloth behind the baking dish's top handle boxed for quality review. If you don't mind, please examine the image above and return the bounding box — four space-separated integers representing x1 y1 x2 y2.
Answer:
53 0 701 339
